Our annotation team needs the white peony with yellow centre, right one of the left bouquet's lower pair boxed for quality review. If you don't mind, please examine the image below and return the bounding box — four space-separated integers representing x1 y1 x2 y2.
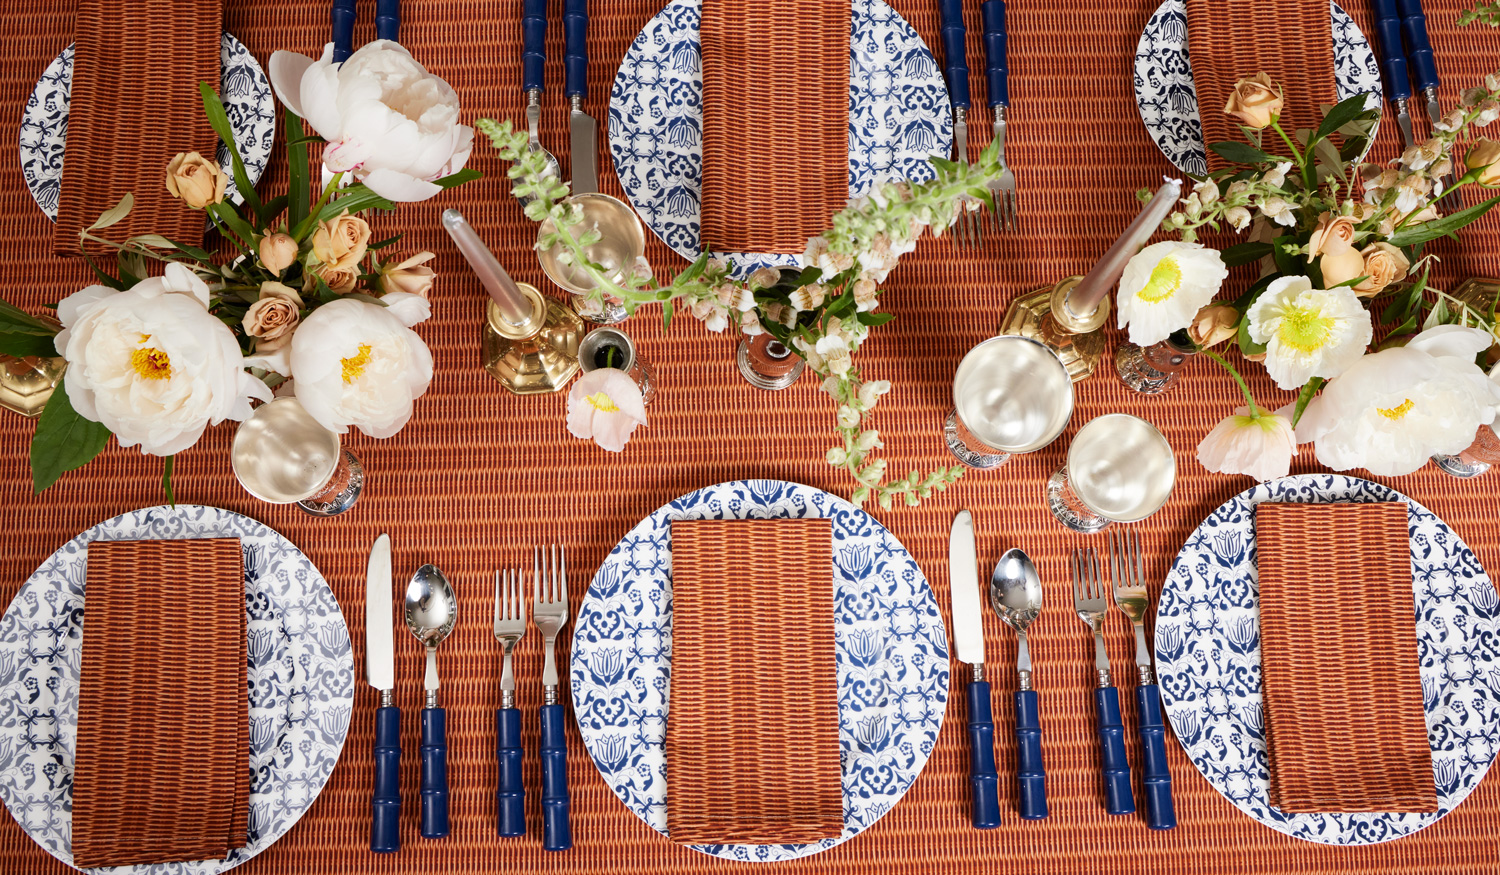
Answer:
291 296 432 438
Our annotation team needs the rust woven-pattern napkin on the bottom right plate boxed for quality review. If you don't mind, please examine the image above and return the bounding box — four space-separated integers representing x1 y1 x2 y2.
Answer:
1256 501 1437 813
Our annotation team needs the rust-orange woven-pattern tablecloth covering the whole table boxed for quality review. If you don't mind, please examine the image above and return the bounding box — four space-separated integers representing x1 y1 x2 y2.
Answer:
0 0 1500 875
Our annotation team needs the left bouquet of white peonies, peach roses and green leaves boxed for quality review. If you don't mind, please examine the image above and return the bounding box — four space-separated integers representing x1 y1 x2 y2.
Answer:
0 41 479 498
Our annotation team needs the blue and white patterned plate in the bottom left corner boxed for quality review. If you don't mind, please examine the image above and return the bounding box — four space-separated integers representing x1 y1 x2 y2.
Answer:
0 504 354 875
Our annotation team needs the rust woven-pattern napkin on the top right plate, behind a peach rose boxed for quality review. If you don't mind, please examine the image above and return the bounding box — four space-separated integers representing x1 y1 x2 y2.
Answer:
1188 0 1338 168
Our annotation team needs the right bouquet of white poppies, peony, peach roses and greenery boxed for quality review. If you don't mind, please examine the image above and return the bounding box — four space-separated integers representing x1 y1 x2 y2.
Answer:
1118 74 1500 480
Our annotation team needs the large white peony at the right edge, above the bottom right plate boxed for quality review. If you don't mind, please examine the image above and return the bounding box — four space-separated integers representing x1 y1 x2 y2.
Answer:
1298 326 1500 476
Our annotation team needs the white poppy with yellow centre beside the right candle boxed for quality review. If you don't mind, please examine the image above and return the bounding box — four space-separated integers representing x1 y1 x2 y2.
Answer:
1116 240 1229 347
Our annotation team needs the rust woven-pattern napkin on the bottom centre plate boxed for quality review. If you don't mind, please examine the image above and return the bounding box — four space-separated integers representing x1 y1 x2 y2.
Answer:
666 519 843 845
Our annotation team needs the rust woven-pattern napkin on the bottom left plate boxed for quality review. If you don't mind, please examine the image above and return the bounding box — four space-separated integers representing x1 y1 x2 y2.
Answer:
74 537 251 869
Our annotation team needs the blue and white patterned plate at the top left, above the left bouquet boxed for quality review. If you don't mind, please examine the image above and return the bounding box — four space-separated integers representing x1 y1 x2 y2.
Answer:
21 33 276 222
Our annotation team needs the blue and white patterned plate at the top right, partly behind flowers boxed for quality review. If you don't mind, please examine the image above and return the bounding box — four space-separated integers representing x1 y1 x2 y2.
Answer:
1136 0 1380 176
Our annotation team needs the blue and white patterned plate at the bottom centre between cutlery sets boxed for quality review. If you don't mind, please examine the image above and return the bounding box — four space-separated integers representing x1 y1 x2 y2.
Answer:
572 480 948 863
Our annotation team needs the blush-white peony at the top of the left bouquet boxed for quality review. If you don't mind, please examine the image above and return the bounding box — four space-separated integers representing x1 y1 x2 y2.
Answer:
270 39 474 201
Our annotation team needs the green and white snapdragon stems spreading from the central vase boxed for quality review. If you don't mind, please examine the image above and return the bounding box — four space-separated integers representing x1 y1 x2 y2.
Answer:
476 119 1002 509
